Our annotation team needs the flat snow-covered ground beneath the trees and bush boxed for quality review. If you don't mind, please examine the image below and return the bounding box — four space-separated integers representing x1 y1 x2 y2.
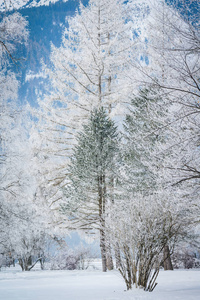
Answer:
0 269 200 300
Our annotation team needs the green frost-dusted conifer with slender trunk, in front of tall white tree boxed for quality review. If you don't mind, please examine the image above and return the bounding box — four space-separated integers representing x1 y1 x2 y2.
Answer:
63 108 118 271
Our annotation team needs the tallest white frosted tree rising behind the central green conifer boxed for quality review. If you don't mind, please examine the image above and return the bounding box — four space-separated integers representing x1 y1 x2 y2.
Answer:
34 0 148 211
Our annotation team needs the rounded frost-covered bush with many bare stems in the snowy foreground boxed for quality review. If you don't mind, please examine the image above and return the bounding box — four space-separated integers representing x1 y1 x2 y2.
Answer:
111 192 193 291
